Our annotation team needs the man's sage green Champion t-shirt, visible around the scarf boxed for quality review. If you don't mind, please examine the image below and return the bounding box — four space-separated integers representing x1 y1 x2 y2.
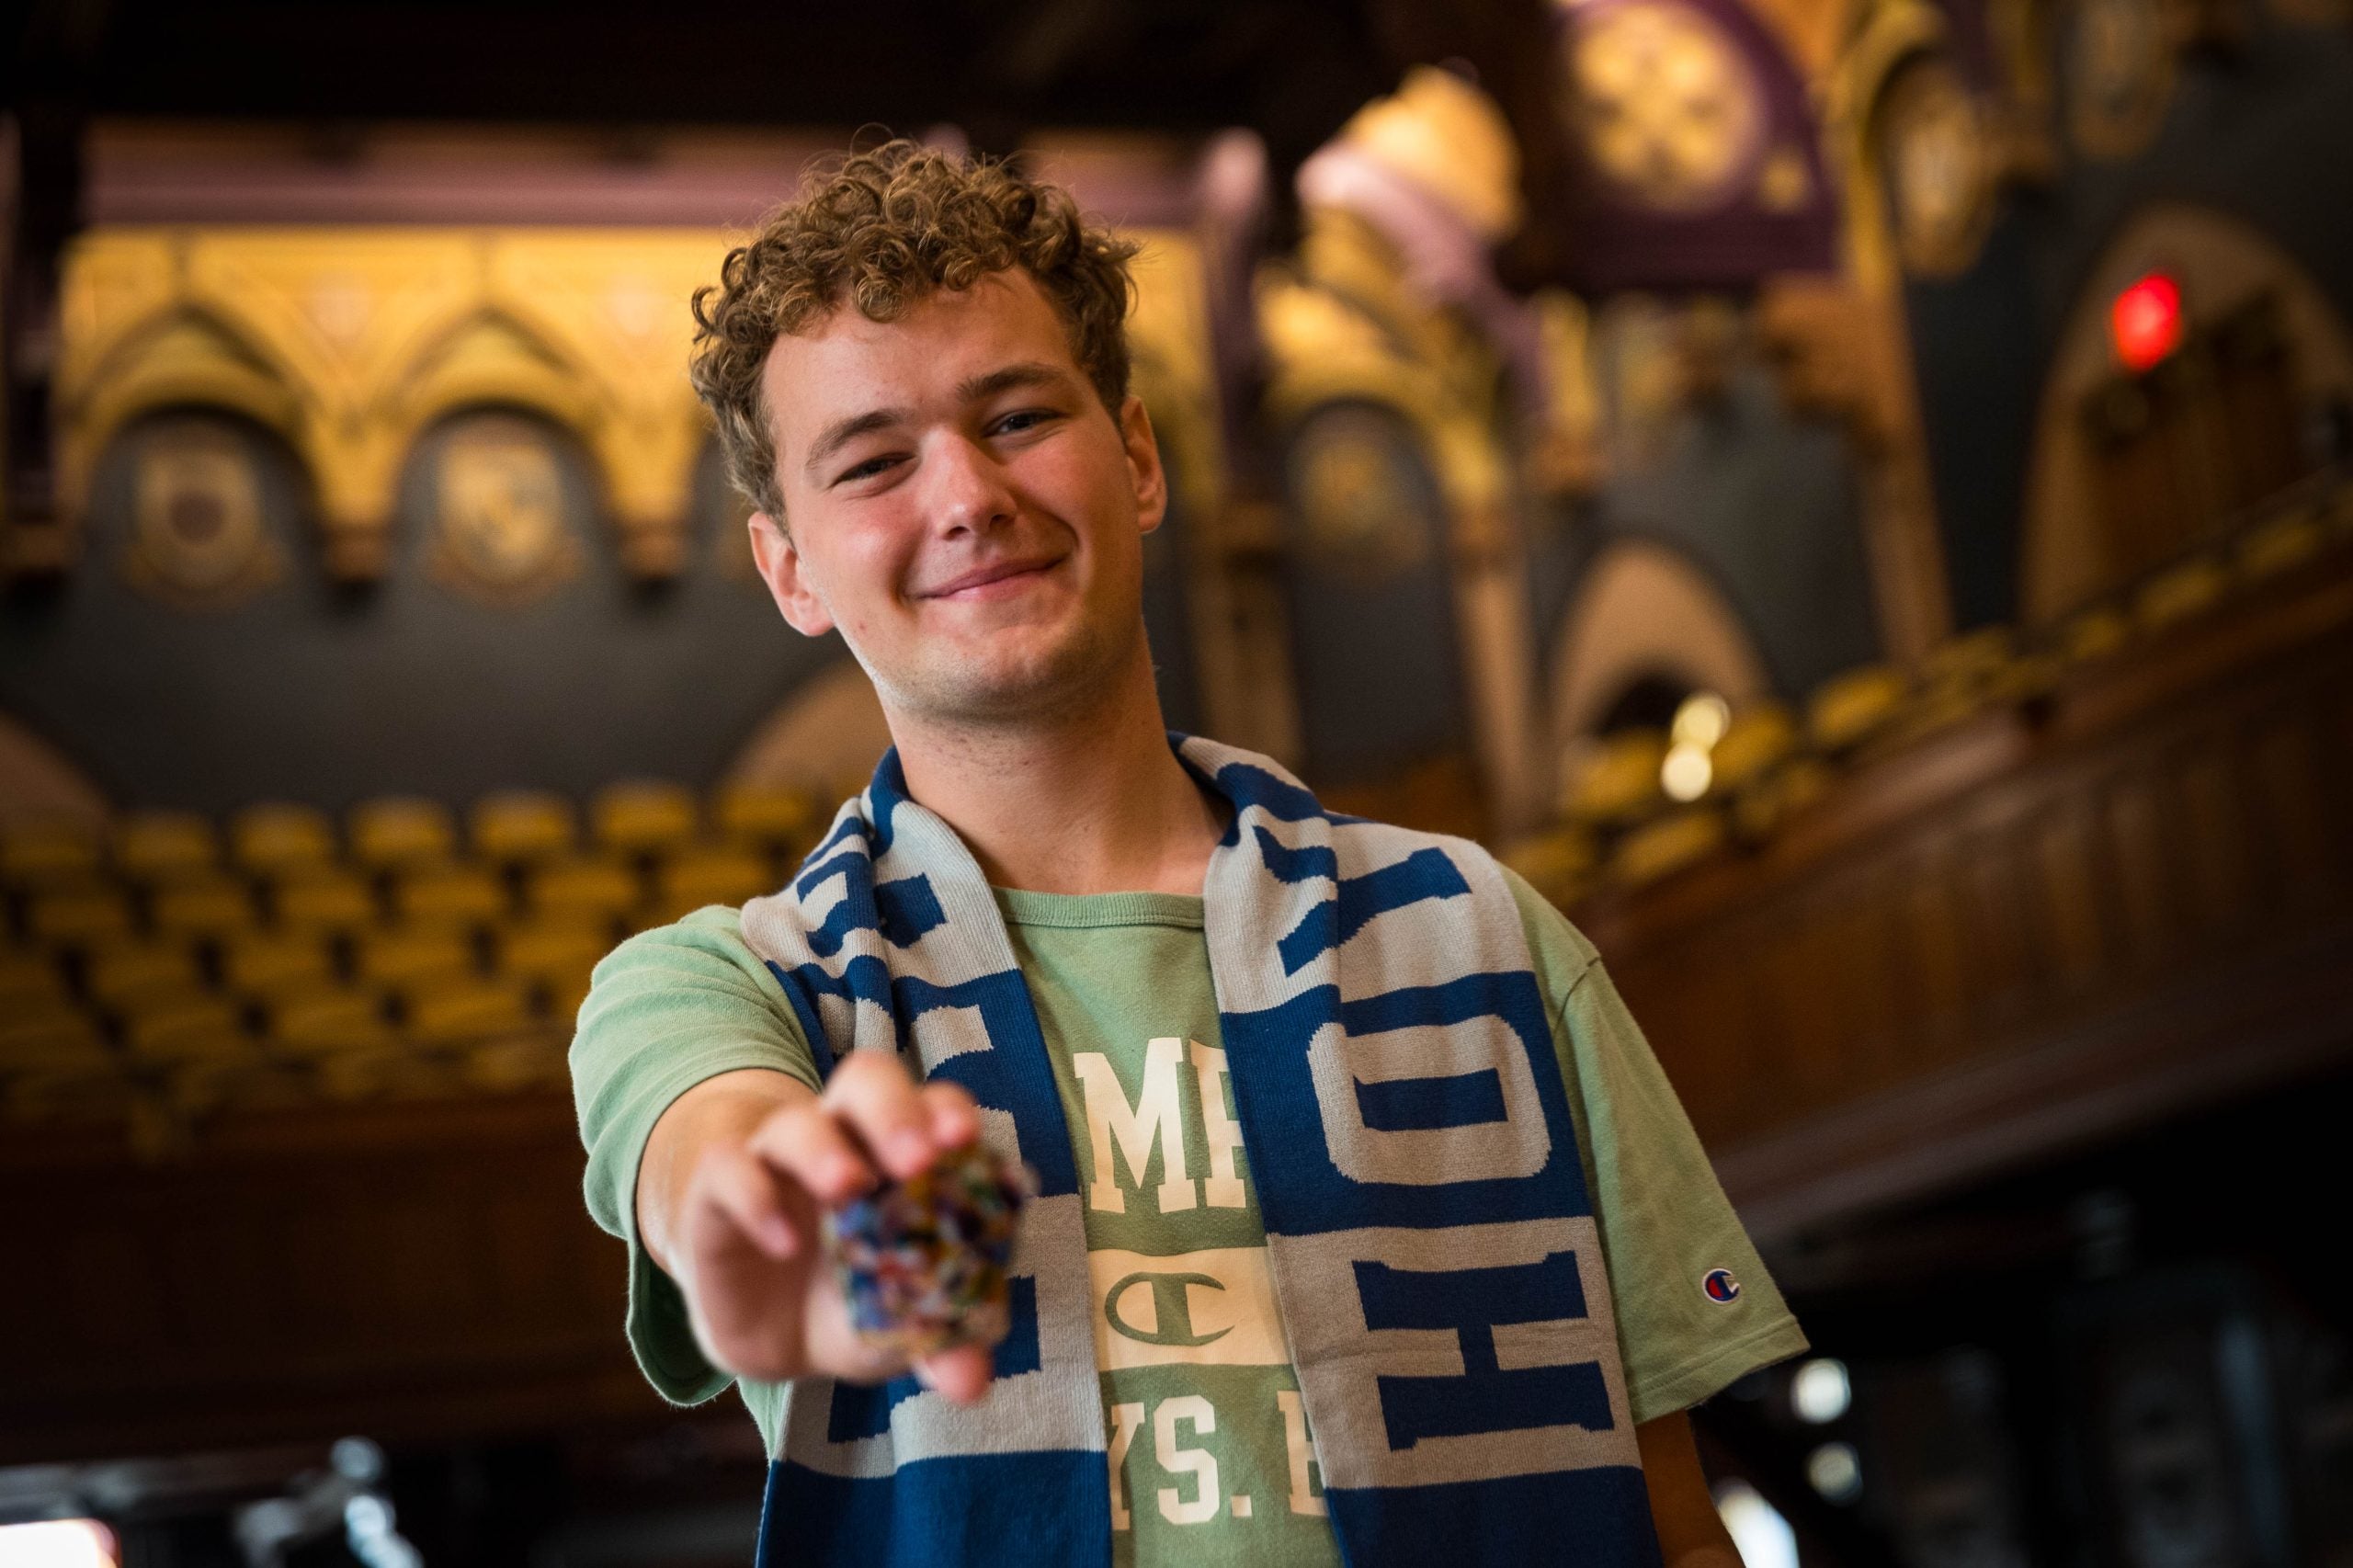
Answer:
572 873 1805 1568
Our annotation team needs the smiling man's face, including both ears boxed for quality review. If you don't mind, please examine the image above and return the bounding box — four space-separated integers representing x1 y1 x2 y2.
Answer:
753 268 1167 722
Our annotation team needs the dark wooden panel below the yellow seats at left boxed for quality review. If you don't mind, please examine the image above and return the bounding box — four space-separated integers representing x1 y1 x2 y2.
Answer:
0 1097 659 1462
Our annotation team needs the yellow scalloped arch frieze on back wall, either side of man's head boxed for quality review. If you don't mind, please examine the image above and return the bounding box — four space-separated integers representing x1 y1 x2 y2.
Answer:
56 223 1219 597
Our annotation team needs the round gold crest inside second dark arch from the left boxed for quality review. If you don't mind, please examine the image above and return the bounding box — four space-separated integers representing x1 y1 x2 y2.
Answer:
395 403 600 609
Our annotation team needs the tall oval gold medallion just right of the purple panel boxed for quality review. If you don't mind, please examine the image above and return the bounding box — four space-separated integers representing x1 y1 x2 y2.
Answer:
1878 56 1995 278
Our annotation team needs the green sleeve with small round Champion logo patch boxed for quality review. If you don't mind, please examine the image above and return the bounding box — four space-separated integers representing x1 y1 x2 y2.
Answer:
1506 873 1805 1422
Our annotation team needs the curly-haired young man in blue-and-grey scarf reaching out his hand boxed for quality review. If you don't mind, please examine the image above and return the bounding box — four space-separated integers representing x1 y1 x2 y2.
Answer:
572 143 1805 1568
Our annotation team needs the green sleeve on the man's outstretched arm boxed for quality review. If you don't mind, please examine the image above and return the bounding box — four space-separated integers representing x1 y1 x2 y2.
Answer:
572 906 819 1403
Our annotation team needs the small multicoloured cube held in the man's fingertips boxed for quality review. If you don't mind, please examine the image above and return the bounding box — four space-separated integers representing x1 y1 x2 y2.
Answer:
826 1144 1038 1356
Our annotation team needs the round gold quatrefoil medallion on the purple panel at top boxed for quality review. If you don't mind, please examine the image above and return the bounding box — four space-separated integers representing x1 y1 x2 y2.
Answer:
1567 0 1765 212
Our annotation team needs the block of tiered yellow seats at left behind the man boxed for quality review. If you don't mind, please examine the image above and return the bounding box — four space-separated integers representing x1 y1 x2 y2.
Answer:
0 784 821 1119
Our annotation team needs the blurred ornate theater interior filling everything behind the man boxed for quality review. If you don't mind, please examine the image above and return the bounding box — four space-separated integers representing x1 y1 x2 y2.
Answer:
0 0 2353 1568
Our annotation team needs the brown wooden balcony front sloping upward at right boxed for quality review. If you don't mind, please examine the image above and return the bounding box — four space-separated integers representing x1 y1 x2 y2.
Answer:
1574 546 2353 1241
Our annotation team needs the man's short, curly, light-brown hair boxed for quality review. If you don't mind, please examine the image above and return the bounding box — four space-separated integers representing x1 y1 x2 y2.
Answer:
689 139 1136 523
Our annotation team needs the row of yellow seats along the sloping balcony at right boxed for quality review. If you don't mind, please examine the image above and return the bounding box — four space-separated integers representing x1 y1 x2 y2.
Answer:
1506 471 2353 904
